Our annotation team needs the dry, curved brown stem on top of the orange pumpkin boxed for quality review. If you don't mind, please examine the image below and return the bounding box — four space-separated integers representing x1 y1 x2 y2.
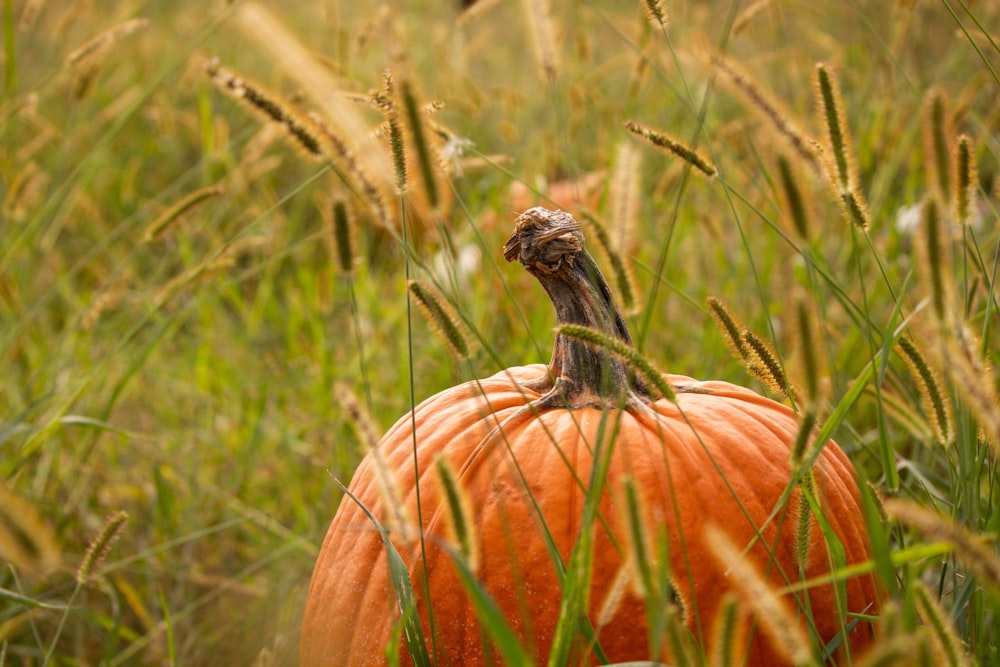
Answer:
503 206 651 409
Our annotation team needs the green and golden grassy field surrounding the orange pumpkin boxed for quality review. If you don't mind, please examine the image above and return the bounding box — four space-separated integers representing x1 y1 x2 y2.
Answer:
0 0 1000 665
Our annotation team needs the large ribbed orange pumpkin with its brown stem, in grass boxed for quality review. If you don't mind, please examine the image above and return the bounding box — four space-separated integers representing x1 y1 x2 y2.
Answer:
300 207 877 666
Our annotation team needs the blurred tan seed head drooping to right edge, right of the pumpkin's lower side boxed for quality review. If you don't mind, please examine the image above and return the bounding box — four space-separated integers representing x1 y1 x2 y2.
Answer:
884 498 1000 592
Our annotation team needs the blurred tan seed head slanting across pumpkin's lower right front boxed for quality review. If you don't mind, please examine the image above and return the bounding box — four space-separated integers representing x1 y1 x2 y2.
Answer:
705 524 817 665
